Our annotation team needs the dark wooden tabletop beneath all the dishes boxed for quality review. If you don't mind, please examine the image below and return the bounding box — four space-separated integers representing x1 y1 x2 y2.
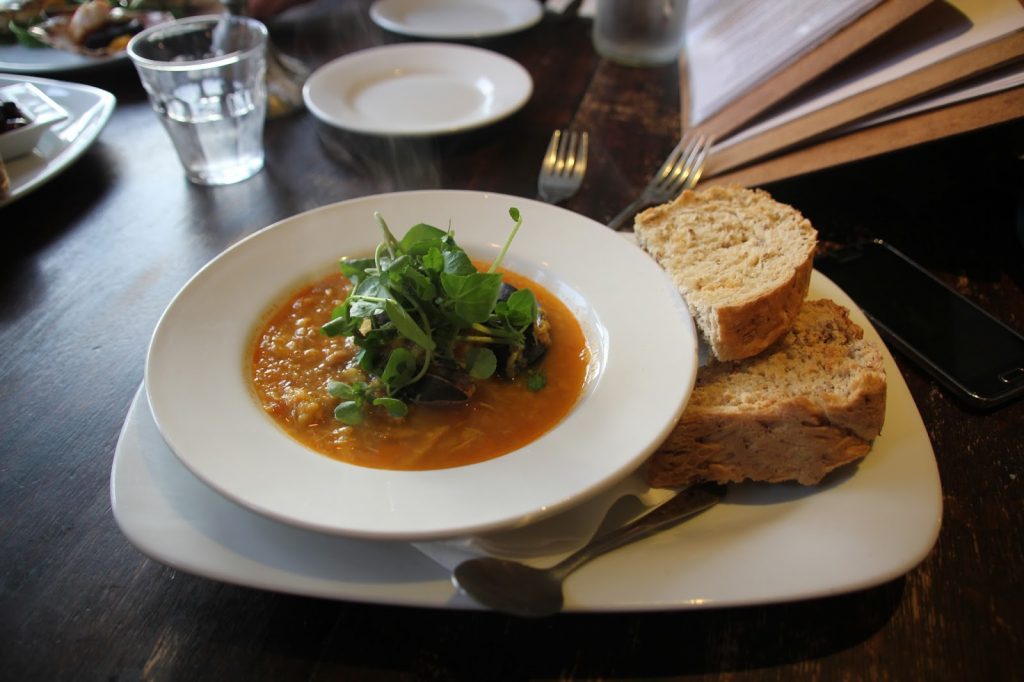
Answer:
0 0 1024 680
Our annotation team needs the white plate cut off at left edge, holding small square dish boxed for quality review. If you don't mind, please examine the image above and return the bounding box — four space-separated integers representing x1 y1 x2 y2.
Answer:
0 74 117 206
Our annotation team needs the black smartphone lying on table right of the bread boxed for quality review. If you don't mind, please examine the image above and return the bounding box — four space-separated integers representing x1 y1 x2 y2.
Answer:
814 241 1024 408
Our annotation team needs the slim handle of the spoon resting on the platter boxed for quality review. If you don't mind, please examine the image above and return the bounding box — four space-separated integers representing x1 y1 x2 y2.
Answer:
548 483 725 578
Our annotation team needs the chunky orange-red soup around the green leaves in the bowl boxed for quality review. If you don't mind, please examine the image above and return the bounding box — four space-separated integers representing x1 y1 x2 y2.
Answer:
249 271 590 470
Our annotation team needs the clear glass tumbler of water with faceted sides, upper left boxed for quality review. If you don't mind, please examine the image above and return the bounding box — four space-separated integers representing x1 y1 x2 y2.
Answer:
128 14 267 185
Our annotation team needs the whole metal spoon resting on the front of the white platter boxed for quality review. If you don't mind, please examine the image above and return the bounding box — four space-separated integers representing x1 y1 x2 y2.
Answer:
452 483 725 617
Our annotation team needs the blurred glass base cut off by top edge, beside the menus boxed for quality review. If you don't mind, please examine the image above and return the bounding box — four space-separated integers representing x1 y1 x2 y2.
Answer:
594 0 686 67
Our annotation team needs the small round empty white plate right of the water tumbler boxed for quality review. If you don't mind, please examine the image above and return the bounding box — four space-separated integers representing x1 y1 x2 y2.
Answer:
302 43 534 137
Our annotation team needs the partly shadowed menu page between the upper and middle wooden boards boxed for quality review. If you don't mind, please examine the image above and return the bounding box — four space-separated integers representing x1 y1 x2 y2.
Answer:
716 0 1024 150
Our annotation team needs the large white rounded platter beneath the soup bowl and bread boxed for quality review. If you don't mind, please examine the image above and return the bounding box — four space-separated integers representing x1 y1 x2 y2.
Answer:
111 272 942 611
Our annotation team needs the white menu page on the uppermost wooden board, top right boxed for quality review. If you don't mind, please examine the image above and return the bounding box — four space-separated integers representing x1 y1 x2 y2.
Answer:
686 0 880 125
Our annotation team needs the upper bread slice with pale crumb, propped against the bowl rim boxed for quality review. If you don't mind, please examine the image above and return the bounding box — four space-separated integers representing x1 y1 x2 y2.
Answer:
634 180 817 360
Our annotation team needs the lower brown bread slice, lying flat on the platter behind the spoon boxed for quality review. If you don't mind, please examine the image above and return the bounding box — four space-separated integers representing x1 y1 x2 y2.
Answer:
647 299 886 486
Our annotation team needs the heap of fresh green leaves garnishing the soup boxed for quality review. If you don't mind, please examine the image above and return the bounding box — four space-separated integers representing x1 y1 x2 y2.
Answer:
322 208 544 425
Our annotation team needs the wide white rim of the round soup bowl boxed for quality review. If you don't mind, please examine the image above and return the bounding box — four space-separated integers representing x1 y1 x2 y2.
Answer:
145 190 697 540
